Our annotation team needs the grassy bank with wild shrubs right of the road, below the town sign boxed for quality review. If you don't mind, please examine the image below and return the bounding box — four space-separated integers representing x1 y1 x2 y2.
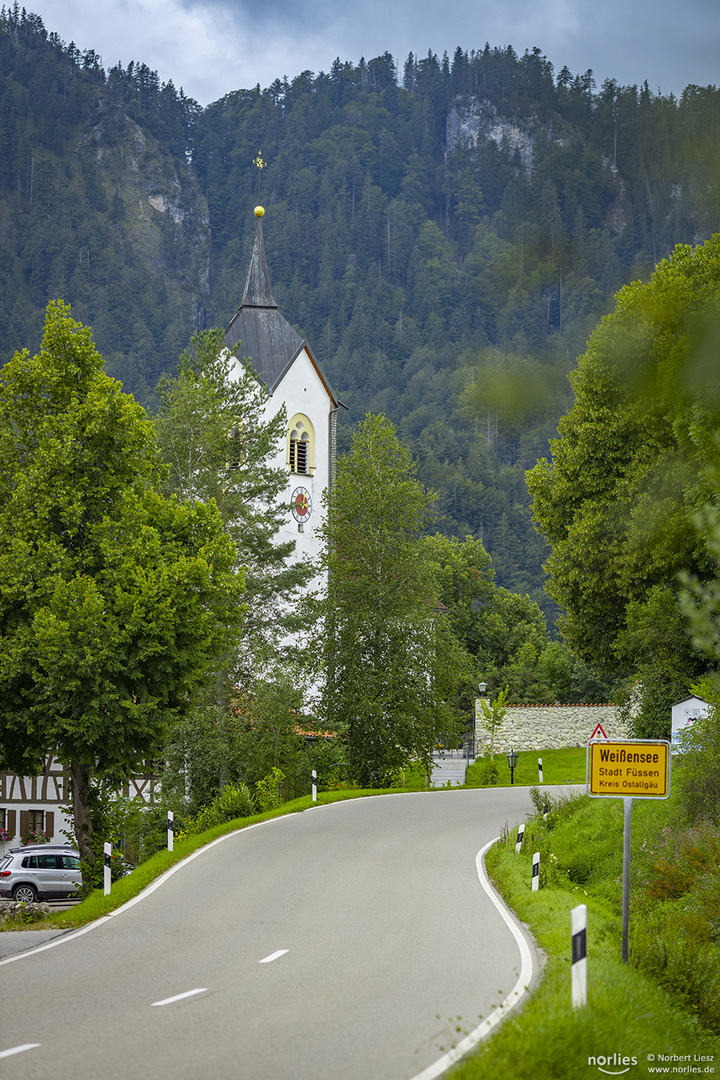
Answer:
451 796 720 1080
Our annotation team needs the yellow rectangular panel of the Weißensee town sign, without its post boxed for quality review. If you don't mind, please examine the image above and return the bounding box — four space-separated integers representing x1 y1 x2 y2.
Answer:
587 739 670 799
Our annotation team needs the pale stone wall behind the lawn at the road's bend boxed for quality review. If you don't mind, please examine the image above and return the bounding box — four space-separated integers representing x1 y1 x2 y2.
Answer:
475 701 628 756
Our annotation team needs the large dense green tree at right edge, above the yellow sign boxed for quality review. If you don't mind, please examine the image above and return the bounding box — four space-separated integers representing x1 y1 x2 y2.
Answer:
528 237 720 735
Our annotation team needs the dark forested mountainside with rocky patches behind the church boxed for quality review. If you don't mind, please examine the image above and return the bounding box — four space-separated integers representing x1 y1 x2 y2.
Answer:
0 8 720 610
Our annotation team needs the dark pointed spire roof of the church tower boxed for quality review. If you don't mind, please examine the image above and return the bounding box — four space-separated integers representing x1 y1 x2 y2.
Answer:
225 206 339 405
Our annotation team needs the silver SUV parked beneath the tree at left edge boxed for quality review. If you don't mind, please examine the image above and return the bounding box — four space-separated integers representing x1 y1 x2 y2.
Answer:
0 843 82 904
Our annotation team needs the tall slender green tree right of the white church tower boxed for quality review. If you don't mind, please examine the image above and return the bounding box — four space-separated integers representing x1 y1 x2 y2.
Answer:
322 416 450 784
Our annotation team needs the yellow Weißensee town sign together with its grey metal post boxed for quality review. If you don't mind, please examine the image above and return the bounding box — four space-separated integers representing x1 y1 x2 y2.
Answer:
587 739 671 963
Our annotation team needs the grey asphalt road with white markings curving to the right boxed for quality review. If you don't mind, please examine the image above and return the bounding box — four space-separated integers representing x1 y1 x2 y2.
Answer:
0 787 539 1080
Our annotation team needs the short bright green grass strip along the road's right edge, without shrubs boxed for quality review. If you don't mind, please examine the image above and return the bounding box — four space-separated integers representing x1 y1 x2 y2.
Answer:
451 798 720 1080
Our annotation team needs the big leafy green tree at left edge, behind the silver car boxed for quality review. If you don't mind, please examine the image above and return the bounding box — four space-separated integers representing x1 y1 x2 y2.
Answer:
0 301 242 864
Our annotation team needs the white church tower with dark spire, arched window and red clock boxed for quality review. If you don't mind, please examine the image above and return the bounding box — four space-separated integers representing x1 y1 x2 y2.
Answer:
225 206 342 574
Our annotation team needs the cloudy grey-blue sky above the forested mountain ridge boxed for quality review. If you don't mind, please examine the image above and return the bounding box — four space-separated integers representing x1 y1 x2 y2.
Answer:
22 0 720 105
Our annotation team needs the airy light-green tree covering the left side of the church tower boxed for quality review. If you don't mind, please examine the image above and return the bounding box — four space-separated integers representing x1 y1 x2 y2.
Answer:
155 329 313 691
